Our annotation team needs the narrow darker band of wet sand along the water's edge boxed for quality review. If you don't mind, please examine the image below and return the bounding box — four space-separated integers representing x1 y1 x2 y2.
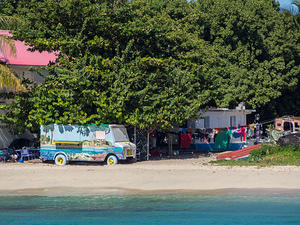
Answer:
0 187 300 197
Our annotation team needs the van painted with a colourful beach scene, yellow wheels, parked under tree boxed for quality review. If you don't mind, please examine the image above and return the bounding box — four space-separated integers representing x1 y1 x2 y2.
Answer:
40 124 136 165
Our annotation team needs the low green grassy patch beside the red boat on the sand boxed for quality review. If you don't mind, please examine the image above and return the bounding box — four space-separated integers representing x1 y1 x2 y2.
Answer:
211 145 300 166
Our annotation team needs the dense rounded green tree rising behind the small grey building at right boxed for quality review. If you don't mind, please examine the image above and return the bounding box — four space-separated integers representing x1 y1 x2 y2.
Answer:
192 0 300 108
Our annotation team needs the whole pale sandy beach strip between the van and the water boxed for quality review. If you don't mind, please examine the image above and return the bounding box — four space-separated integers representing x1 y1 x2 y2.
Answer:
0 156 300 195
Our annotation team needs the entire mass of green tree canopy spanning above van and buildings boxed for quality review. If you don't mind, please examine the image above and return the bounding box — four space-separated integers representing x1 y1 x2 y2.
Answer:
0 0 300 132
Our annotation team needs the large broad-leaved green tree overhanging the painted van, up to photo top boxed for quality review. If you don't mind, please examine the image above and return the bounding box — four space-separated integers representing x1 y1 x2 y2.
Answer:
2 0 212 130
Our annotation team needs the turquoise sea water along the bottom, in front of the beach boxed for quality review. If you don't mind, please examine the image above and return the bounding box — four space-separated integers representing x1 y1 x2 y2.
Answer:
0 194 300 225
